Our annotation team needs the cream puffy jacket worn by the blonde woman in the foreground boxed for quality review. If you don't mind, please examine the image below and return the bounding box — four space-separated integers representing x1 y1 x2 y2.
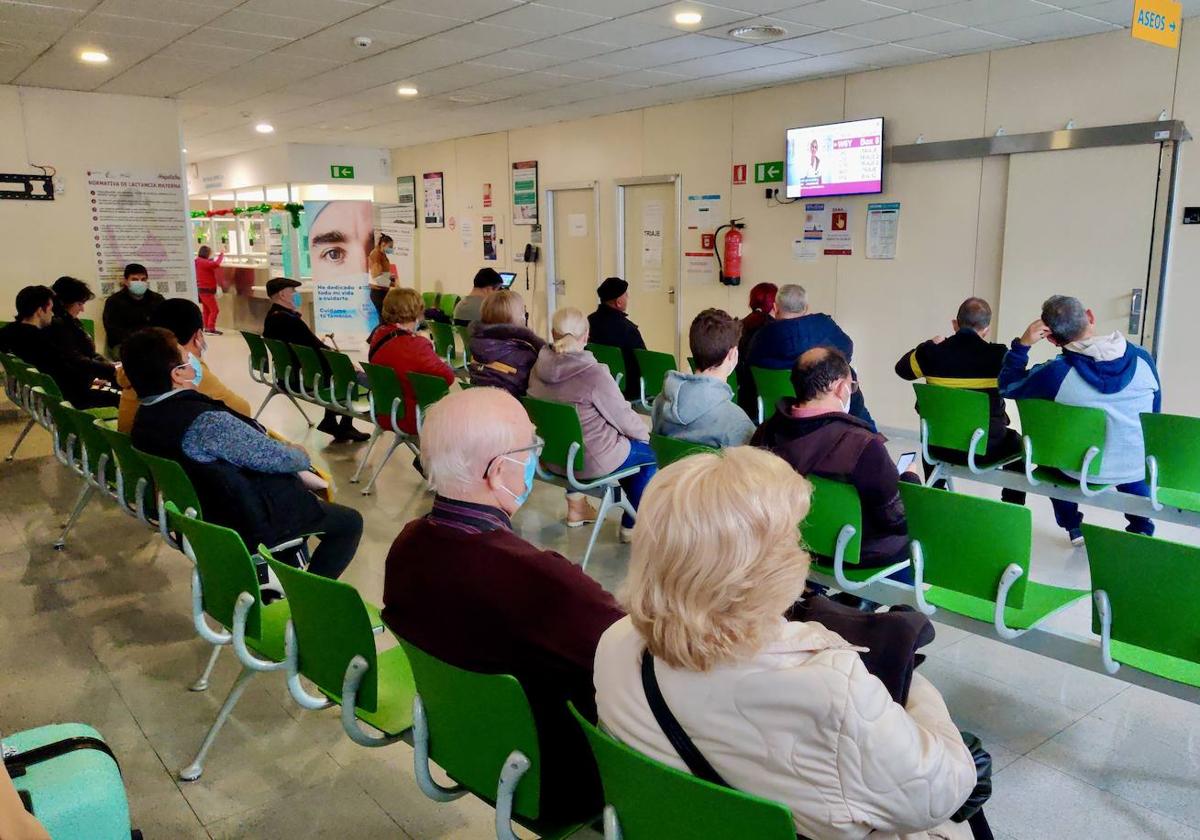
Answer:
595 617 976 840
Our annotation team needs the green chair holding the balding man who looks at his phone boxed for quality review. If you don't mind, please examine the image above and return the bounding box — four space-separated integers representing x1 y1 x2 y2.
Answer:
800 475 920 592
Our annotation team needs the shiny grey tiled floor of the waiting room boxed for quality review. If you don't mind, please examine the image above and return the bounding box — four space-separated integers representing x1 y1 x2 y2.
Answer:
0 334 1200 840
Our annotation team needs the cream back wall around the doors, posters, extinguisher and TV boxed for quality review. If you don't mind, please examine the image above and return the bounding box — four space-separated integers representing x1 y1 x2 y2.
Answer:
391 31 1200 428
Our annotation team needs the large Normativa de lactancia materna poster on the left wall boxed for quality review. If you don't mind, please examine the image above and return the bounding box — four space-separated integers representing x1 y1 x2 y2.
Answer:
88 169 196 300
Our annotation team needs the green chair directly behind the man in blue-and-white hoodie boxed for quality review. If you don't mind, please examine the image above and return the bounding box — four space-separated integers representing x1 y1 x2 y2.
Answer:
1016 400 1112 497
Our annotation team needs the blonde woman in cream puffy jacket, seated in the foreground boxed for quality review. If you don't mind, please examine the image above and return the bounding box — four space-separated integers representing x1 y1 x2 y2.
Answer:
595 446 977 840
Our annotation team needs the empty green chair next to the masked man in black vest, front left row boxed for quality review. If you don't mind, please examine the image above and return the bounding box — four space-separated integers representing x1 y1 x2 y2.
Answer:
164 502 292 781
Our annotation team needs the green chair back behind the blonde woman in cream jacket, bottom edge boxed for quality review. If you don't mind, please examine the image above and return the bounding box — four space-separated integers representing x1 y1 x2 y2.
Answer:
570 704 796 840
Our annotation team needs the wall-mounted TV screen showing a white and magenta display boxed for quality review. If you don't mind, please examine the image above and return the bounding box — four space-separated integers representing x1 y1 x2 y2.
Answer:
786 116 883 198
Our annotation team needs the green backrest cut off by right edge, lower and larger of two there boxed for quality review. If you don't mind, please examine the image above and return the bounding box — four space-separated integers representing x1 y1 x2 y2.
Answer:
1084 522 1200 662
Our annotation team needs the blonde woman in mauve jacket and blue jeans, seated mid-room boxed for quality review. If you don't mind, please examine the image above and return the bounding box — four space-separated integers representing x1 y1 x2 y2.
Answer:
529 307 656 542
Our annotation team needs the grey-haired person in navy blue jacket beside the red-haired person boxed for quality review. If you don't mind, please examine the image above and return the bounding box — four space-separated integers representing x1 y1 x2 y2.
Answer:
750 284 876 432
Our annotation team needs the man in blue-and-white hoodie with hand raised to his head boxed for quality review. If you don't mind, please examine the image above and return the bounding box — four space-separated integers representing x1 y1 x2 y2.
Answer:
998 295 1163 546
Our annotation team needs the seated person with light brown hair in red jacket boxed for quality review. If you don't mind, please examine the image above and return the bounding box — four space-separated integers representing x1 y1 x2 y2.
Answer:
367 288 454 434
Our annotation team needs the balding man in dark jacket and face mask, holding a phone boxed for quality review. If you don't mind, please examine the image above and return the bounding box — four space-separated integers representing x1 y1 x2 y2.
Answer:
750 347 920 573
